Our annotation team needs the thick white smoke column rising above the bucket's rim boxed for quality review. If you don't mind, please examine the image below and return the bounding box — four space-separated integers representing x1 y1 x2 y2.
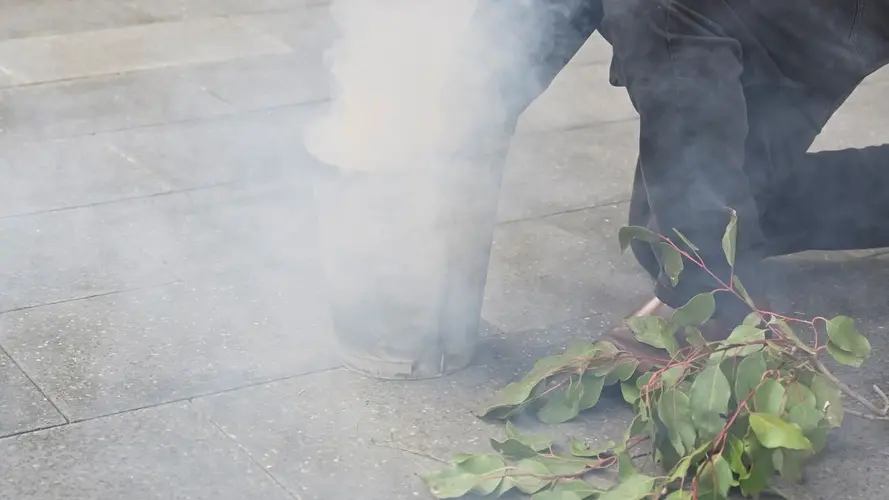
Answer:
308 0 483 170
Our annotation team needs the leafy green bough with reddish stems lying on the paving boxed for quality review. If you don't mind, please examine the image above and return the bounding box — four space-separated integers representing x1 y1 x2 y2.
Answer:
422 213 889 500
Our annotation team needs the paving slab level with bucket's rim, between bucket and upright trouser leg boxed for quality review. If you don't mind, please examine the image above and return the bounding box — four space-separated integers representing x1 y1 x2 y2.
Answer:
499 121 639 221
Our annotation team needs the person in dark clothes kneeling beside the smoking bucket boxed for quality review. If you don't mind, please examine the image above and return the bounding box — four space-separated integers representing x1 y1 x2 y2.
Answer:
458 0 889 360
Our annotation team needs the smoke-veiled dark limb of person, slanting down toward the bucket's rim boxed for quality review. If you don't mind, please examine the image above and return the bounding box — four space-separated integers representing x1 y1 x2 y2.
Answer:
449 0 602 145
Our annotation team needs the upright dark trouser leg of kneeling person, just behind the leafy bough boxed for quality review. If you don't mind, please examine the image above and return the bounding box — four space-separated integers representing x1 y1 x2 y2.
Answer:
603 0 764 320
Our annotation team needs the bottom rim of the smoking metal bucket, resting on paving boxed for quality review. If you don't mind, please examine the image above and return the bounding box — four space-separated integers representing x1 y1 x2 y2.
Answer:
340 348 472 380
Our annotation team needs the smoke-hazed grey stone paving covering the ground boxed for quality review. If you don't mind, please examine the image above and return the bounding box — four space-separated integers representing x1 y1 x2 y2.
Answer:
0 0 889 500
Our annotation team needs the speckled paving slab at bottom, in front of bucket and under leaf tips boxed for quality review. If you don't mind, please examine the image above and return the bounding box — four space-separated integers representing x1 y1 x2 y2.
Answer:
194 324 630 500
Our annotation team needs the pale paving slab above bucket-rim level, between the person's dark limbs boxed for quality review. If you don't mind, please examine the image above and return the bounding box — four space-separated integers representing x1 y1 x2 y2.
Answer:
518 62 639 133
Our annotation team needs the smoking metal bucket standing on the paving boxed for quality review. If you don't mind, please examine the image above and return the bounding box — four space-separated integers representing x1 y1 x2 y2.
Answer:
315 155 502 380
